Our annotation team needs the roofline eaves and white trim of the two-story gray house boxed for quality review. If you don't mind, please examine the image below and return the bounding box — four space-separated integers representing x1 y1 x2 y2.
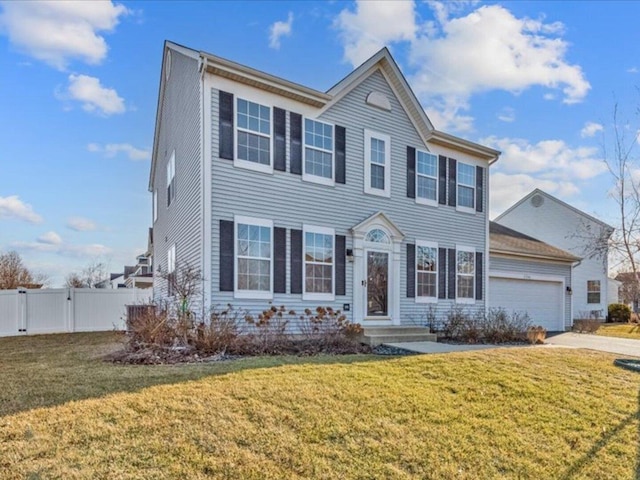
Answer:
149 40 500 191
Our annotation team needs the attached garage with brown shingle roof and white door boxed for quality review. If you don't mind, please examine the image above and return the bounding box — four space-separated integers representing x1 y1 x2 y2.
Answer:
489 222 580 332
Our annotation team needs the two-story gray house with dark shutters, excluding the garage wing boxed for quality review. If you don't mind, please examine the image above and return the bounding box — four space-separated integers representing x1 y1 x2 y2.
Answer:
149 42 499 326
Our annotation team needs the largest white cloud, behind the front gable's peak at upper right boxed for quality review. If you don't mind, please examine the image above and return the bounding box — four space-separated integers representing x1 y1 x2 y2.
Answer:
334 0 591 131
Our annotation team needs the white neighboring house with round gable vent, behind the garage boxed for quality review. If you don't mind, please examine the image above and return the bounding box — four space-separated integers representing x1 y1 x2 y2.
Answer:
495 189 613 319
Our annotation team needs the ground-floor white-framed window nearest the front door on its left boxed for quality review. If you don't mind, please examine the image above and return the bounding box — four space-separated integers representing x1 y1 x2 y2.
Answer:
303 225 335 300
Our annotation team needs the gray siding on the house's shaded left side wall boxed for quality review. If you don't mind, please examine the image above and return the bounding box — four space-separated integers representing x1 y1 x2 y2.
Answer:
153 47 202 307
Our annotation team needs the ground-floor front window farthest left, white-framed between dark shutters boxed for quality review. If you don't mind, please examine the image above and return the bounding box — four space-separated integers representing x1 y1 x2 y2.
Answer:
235 216 273 299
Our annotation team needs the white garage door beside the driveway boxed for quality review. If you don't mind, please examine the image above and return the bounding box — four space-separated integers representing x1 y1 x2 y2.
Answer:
489 277 564 332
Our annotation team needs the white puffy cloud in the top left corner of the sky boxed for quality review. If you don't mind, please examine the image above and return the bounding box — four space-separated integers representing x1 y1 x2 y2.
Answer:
0 1 130 70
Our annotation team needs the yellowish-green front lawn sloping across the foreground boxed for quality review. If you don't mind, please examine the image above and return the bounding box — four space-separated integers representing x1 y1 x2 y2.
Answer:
0 334 640 479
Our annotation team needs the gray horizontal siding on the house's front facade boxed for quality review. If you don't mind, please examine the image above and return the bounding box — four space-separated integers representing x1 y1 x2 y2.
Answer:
210 72 488 324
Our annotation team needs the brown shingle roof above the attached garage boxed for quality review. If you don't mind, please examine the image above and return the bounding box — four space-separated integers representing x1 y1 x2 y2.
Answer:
489 222 580 262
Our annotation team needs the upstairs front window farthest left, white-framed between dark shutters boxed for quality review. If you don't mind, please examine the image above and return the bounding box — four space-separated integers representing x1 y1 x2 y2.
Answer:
235 98 273 173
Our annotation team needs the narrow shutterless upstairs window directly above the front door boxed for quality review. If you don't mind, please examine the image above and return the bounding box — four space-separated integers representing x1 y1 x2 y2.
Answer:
364 130 391 197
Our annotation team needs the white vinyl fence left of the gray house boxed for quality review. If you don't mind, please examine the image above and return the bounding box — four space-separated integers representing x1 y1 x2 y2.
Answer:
0 288 152 337
